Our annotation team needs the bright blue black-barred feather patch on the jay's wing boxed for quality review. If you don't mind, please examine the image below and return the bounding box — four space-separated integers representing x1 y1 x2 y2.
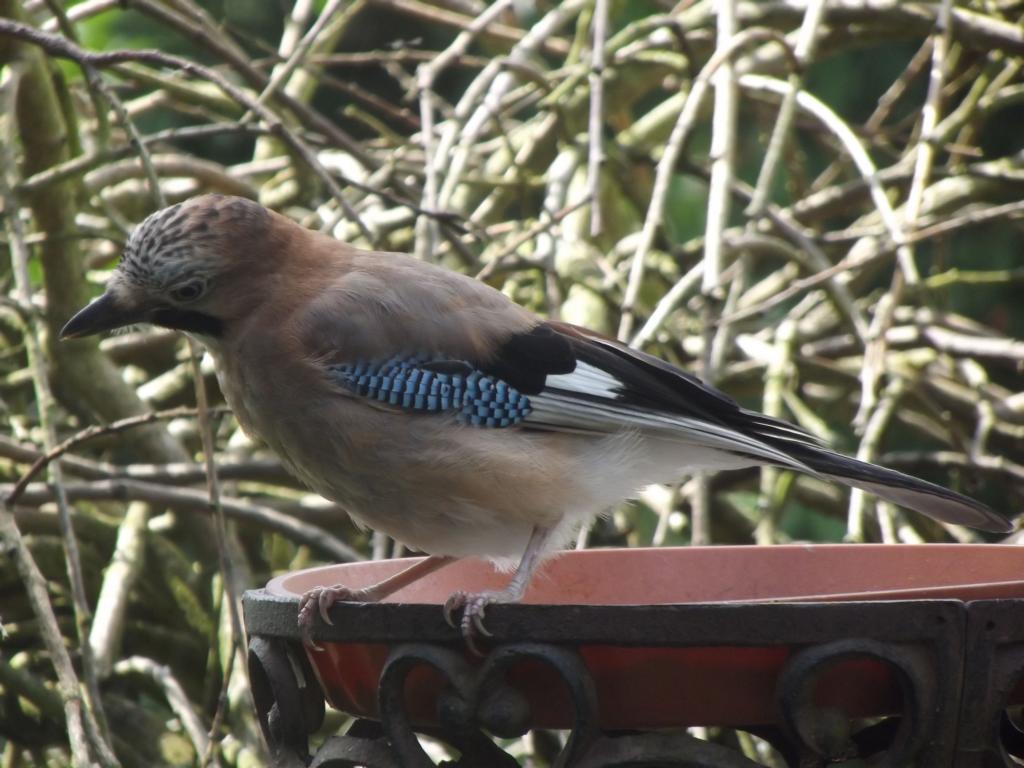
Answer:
328 357 530 427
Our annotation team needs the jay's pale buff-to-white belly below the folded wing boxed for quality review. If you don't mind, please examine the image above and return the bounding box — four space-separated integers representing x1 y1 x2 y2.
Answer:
292 426 746 567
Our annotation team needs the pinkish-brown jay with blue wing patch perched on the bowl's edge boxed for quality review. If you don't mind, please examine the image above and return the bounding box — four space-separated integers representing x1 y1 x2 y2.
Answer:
60 196 1012 647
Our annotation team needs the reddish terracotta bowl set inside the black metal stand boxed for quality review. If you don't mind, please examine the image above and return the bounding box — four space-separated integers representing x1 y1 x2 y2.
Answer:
267 544 1024 729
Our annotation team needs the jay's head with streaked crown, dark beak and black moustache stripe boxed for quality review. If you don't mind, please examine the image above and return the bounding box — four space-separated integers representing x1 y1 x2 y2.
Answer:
60 195 271 339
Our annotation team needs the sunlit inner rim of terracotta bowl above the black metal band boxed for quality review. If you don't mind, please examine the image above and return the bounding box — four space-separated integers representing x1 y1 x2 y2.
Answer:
266 544 1024 605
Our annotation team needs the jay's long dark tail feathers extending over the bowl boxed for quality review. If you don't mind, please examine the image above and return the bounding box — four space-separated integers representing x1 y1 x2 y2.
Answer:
785 443 1013 534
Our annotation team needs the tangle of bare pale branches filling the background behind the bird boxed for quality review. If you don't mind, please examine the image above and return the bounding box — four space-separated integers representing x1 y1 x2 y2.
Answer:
0 0 1024 768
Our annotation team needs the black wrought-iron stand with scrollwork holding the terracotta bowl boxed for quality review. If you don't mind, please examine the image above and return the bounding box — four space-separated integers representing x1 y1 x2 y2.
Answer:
245 591 1024 768
